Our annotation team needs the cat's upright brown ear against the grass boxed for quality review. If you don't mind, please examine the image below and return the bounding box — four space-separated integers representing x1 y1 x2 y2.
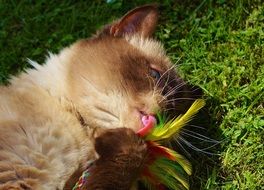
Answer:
101 4 158 37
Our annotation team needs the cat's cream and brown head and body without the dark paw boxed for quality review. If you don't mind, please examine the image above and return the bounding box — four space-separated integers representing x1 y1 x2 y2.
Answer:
0 5 200 190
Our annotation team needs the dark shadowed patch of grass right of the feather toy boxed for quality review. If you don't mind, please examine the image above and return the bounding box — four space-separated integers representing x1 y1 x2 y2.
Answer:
182 100 223 190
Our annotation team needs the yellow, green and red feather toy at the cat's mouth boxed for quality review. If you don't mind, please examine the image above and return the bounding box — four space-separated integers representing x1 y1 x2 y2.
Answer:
138 99 205 190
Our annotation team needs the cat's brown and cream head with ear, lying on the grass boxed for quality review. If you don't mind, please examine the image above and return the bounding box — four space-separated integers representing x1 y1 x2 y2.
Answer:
64 5 202 130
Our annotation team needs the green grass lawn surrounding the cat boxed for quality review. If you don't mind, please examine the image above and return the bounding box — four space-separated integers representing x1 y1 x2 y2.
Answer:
0 0 264 190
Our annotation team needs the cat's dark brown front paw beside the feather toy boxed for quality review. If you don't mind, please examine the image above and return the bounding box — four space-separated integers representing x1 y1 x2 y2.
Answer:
81 128 148 190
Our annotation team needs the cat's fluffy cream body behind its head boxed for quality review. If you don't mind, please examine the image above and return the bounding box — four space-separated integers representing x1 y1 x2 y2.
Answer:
0 49 94 189
